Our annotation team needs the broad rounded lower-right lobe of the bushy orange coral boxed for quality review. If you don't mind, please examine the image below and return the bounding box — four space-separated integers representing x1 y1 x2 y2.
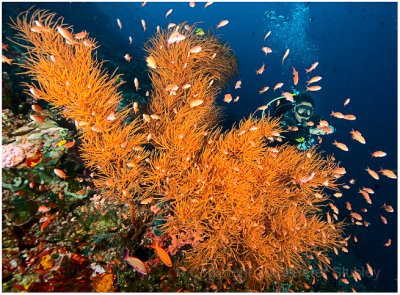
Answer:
155 118 341 286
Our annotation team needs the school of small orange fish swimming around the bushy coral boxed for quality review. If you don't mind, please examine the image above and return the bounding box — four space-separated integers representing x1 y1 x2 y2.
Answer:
2 1 397 291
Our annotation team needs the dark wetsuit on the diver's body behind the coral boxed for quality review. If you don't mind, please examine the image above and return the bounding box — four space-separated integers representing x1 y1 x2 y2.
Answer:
280 110 320 151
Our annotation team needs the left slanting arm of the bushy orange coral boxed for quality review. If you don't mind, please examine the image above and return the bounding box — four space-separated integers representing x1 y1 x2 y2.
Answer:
12 10 148 210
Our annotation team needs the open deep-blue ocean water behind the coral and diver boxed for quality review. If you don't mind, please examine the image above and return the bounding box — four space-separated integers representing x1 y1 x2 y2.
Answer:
2 2 398 291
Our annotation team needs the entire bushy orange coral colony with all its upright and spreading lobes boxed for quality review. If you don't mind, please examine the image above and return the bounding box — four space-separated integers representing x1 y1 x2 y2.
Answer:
13 11 345 287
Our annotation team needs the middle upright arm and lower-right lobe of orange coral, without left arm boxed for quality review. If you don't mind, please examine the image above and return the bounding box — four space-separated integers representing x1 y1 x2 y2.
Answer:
141 24 342 286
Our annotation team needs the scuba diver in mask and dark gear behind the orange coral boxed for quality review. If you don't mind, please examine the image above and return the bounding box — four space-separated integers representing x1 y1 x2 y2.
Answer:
263 91 335 151
